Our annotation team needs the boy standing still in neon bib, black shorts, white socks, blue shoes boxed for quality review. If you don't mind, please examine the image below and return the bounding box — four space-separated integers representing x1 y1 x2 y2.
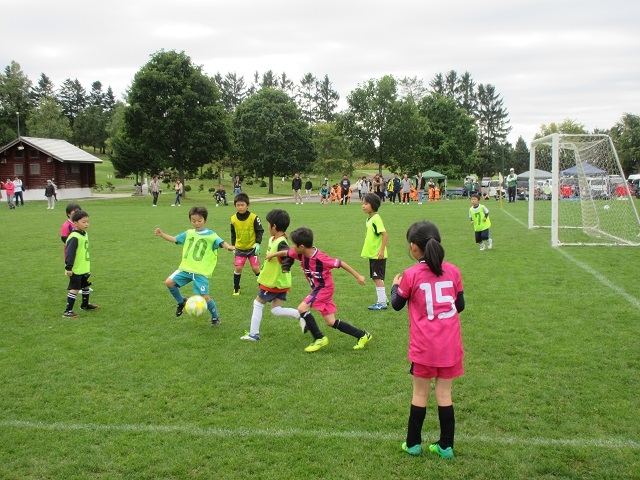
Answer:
360 193 389 310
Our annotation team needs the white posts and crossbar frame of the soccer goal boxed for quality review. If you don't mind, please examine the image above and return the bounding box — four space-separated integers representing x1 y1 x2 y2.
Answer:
528 133 640 247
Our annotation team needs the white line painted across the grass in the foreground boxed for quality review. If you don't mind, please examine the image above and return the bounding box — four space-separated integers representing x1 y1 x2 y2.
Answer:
0 420 640 450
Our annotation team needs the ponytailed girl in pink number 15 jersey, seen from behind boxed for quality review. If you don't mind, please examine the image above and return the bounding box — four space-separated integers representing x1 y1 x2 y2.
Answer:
391 222 464 458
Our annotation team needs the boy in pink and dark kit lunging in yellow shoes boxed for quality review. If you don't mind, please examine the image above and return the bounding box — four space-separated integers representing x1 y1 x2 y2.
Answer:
266 227 373 352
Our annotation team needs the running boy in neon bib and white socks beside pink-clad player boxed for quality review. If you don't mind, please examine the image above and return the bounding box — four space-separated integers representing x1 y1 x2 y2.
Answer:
240 209 304 341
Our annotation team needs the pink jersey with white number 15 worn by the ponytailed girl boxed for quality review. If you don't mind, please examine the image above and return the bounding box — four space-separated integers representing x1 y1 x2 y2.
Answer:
398 262 464 367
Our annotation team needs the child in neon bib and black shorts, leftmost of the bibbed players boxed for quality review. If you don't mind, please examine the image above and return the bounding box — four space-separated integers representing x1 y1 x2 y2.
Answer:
62 210 99 318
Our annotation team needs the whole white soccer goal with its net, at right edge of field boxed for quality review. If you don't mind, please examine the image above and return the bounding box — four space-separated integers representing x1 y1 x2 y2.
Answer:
529 133 640 246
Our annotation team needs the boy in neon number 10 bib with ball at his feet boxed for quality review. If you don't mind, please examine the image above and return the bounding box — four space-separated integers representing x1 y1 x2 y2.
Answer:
154 207 233 326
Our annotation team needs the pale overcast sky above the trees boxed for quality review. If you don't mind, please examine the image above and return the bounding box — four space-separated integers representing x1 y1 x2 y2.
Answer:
0 0 640 143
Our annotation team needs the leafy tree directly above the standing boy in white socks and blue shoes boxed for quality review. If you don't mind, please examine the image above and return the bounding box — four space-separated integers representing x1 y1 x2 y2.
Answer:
337 75 398 174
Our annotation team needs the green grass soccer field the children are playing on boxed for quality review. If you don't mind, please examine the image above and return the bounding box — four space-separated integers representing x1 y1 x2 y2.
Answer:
0 192 640 479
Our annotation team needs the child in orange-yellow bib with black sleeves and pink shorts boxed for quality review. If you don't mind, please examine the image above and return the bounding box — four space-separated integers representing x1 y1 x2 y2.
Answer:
231 193 264 296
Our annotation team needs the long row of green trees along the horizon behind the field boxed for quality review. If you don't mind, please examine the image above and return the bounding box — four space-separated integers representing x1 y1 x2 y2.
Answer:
0 50 640 191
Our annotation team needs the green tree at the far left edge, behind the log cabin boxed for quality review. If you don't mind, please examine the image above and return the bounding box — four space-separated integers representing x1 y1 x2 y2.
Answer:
0 61 34 145
